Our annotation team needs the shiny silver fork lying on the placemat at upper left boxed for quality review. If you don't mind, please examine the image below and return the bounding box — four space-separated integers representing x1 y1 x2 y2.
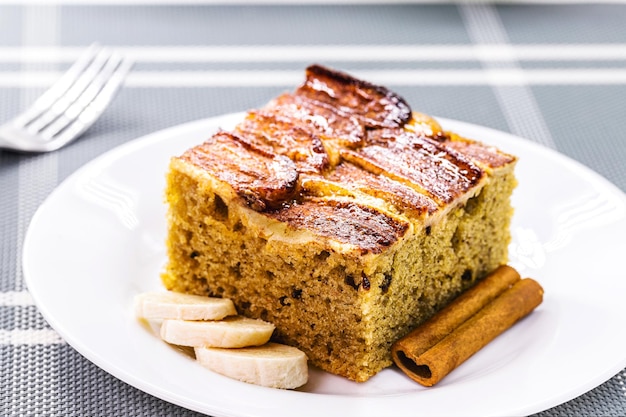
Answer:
0 44 132 152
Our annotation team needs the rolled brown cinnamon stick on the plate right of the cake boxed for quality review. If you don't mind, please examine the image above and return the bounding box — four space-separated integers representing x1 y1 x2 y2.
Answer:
391 266 543 386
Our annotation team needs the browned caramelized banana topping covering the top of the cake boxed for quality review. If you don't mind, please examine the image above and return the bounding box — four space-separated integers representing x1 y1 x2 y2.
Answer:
176 65 514 252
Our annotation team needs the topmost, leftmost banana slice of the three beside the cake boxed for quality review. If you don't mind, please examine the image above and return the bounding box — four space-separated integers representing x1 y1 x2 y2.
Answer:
135 291 237 320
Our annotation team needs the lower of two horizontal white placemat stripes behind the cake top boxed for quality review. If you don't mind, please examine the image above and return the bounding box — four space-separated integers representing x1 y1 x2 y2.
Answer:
0 68 626 88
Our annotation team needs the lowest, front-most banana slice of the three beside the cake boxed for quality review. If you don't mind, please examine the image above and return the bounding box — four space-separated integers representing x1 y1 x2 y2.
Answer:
195 342 309 389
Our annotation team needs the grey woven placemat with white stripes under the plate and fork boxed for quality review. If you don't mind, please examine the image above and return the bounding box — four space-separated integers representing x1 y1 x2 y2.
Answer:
0 3 626 417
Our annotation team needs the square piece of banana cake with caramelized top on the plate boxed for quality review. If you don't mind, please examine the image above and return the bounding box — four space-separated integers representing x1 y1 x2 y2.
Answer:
162 65 517 382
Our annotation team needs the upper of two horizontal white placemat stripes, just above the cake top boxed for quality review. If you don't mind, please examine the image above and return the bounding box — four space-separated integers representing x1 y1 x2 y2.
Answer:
0 44 626 63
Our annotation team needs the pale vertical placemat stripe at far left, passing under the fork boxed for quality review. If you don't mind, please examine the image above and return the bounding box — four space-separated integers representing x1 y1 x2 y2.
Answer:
12 15 65 410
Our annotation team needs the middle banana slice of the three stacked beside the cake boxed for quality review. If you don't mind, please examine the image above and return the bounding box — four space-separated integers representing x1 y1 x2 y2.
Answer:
161 316 275 348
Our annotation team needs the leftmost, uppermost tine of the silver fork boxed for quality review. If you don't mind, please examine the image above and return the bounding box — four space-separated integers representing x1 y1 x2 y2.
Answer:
13 43 100 127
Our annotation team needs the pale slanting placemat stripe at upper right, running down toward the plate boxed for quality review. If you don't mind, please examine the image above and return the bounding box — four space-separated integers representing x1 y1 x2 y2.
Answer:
459 4 556 148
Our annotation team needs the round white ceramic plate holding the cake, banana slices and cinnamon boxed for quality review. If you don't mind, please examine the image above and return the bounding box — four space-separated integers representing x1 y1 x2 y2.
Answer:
23 114 626 417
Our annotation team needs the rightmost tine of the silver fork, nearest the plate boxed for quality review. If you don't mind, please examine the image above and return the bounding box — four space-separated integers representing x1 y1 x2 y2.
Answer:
39 55 133 150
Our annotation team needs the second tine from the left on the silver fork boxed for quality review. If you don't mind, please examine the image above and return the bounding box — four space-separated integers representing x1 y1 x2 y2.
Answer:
25 49 111 134
